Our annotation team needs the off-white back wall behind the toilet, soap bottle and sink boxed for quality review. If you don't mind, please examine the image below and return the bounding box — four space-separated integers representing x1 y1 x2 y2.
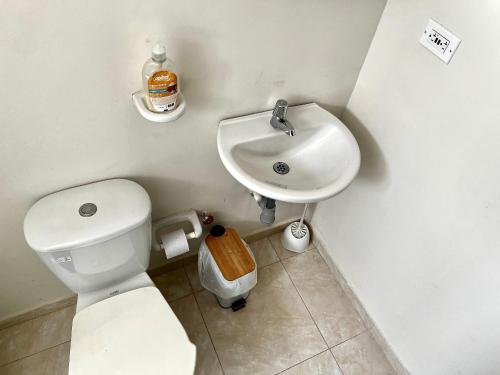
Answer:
0 0 385 319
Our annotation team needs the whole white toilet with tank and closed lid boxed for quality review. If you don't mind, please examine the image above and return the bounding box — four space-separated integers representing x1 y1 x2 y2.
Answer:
24 179 196 375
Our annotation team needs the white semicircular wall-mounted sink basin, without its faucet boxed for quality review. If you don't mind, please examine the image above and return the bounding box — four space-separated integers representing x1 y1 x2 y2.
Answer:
217 103 360 203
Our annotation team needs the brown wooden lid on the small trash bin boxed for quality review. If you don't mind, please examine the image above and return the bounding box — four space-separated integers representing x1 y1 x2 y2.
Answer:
205 225 255 281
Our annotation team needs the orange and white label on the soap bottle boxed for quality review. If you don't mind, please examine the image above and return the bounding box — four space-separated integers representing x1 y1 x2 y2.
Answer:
148 70 178 112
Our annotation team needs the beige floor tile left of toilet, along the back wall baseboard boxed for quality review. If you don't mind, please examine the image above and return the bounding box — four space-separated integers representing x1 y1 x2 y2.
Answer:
0 305 76 365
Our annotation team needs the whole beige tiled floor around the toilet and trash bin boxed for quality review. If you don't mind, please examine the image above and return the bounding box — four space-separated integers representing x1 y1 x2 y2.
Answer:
0 235 395 375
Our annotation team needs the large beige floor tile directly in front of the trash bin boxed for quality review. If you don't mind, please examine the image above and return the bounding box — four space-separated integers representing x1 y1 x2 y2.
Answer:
196 262 326 375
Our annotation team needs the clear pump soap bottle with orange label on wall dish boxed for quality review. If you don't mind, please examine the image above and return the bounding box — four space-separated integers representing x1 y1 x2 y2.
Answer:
142 43 180 112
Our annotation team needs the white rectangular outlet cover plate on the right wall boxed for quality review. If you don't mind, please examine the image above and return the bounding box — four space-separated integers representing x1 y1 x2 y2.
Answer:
420 19 461 64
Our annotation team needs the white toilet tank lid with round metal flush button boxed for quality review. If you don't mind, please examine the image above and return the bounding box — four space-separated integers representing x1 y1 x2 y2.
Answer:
24 179 151 252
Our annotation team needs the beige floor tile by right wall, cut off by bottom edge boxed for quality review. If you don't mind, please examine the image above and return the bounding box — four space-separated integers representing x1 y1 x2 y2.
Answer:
332 332 396 375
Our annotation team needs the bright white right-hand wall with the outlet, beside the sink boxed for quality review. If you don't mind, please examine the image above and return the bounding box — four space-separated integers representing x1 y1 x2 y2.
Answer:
313 0 500 375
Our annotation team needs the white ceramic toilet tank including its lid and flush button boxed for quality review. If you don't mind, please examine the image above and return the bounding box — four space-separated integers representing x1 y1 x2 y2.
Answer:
24 179 151 293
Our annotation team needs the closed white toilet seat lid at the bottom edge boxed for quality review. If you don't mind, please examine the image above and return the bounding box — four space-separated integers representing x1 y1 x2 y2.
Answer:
69 287 196 375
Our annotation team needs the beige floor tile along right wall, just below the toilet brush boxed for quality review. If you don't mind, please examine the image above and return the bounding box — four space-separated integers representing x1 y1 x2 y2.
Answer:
283 249 366 347
